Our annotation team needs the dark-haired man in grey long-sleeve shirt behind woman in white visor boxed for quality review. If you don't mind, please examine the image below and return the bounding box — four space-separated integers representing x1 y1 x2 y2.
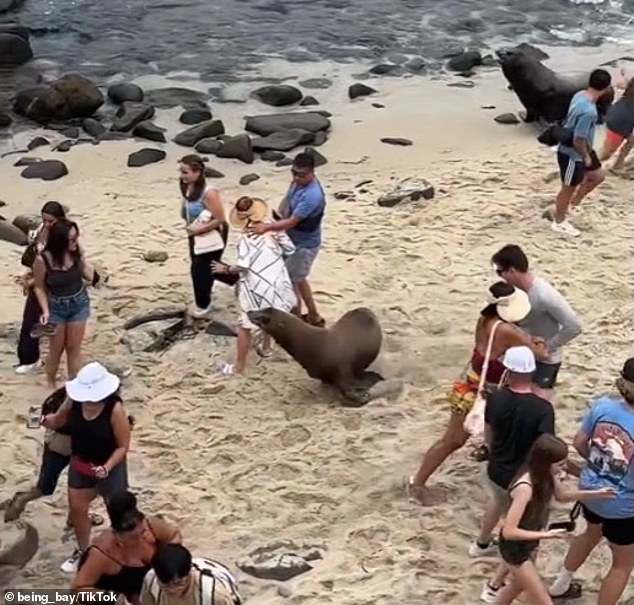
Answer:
491 244 581 399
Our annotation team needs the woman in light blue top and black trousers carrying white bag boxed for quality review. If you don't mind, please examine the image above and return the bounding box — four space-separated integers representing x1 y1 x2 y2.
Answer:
179 154 228 319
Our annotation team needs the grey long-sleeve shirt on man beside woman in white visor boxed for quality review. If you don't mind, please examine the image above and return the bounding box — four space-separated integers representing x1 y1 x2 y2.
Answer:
519 277 581 363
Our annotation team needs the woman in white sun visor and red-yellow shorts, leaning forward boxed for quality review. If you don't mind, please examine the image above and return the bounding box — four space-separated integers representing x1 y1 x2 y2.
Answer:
409 282 547 504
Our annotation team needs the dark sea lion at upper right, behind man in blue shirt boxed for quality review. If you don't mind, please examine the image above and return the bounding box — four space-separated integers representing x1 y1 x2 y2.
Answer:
497 47 614 122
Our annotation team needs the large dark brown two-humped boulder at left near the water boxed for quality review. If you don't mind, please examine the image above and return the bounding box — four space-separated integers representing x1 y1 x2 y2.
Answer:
13 74 104 123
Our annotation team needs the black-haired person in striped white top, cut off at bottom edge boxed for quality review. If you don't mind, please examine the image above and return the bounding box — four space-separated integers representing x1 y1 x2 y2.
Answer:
141 544 242 605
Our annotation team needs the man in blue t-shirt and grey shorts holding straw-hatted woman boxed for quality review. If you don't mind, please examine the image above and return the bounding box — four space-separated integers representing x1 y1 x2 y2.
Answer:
250 153 326 326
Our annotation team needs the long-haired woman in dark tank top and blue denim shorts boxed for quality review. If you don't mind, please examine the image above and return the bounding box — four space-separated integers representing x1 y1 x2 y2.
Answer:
33 220 94 389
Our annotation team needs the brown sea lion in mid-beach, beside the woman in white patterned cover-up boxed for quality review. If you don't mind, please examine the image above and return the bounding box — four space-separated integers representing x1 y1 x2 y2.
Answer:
248 308 383 407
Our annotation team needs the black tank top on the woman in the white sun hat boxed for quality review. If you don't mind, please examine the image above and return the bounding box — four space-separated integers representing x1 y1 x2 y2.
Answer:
68 397 121 465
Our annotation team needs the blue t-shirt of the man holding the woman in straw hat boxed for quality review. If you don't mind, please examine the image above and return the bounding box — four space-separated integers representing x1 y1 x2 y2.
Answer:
288 179 326 248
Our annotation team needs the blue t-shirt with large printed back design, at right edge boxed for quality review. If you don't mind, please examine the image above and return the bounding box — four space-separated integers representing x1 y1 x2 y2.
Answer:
579 396 634 519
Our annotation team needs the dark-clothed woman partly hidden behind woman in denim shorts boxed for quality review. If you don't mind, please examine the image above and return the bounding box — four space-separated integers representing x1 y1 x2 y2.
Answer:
15 202 66 374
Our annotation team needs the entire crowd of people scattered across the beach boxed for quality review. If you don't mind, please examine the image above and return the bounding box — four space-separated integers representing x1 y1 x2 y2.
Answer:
5 69 634 605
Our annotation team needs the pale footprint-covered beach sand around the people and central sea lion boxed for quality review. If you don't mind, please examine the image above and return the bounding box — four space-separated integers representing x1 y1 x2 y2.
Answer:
0 51 634 605
